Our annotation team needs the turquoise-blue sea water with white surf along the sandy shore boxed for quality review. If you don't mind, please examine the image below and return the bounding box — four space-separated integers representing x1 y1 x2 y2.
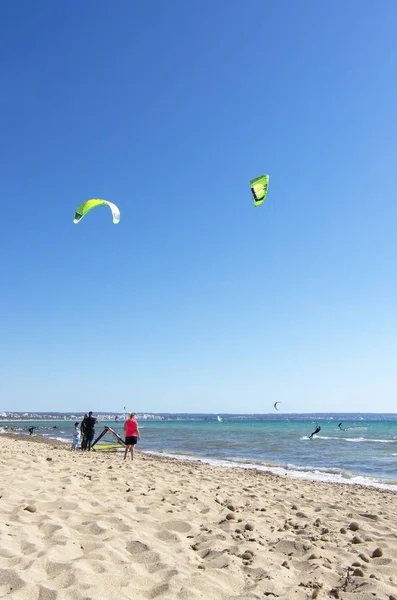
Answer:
0 414 397 491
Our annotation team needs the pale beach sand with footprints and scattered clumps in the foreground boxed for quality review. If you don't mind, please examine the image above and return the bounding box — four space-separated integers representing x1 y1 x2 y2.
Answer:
0 435 397 600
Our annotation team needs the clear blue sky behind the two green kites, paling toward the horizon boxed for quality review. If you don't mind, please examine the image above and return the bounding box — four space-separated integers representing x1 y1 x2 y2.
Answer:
0 0 397 413
